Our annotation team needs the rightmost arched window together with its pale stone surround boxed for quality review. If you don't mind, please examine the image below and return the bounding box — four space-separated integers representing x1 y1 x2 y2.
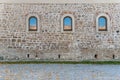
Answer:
96 13 110 31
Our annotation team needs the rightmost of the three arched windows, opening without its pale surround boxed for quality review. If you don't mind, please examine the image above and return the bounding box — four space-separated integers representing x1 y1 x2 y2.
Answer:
98 16 107 31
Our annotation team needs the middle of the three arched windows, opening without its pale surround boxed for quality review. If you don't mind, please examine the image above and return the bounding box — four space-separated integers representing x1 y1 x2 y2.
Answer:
63 16 73 31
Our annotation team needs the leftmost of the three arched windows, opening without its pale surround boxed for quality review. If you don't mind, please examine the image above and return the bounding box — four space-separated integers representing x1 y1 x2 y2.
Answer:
29 16 38 31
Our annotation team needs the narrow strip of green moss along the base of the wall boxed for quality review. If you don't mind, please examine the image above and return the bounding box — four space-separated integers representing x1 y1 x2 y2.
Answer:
0 60 120 65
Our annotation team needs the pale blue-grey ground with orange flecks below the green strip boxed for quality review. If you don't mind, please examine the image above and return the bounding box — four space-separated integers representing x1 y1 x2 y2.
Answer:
0 64 120 80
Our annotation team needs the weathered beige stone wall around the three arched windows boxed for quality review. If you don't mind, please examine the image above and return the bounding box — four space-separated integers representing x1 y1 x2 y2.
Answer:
0 3 120 60
